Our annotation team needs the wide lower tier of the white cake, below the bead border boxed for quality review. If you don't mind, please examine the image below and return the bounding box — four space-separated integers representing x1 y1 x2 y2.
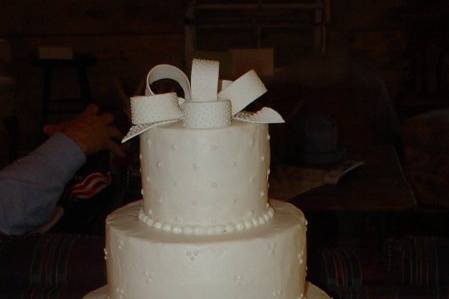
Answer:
105 201 307 299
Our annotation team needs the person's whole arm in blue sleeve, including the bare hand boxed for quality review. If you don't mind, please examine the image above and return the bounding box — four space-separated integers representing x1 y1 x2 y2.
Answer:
0 105 124 235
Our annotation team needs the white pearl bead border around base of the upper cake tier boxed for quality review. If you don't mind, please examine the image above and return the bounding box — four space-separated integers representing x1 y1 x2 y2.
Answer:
139 207 274 236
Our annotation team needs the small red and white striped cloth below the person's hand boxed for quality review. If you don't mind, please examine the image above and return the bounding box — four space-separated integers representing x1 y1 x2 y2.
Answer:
70 172 112 199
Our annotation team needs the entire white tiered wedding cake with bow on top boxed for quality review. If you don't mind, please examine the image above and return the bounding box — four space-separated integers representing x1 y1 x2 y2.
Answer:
86 59 328 299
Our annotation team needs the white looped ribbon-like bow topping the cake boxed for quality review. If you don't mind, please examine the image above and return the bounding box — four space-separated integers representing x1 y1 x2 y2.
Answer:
122 59 285 142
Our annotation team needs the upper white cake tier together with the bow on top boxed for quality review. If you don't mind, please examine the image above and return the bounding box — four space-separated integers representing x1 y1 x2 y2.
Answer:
124 59 284 235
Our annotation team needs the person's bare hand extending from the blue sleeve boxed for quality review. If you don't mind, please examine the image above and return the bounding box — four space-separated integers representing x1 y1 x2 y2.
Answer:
44 104 125 157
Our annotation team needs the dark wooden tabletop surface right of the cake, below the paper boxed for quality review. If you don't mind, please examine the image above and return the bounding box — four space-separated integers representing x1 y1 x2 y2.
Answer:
290 146 416 212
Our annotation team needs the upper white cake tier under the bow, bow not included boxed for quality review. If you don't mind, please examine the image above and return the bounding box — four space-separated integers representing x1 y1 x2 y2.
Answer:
140 121 273 229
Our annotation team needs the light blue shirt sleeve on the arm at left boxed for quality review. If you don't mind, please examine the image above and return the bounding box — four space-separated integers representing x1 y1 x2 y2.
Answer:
0 134 86 235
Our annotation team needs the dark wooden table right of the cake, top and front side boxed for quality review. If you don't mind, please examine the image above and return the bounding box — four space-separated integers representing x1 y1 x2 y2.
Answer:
274 146 416 250
